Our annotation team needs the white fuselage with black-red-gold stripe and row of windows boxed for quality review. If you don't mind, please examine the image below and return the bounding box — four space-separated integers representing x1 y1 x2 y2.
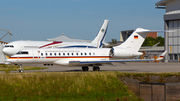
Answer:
7 48 142 66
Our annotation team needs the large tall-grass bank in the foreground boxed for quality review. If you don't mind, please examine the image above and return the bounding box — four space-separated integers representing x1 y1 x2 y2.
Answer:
0 72 142 101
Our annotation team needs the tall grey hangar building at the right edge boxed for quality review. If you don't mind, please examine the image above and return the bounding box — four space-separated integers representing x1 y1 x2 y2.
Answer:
156 0 180 62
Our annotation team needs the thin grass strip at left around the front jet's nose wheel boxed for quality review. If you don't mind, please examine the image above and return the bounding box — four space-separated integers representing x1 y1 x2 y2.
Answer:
0 64 48 73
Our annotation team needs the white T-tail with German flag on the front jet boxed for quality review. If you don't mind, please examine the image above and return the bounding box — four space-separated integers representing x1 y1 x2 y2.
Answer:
114 28 165 52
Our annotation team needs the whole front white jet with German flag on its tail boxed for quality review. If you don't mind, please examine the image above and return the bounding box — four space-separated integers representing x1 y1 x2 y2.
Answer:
7 28 166 72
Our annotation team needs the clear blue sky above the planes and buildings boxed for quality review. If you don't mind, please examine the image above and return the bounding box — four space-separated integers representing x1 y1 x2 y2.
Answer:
0 0 165 42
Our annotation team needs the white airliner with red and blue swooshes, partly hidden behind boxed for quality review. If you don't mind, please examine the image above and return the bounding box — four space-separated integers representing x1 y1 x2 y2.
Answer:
3 20 109 56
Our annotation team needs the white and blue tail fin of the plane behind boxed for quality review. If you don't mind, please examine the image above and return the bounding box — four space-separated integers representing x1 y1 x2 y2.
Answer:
91 20 109 48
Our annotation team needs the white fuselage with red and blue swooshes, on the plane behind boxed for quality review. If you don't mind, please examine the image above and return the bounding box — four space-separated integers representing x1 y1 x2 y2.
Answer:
3 41 97 56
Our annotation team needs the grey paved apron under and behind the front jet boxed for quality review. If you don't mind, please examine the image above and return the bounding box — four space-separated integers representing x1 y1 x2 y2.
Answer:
7 62 180 73
